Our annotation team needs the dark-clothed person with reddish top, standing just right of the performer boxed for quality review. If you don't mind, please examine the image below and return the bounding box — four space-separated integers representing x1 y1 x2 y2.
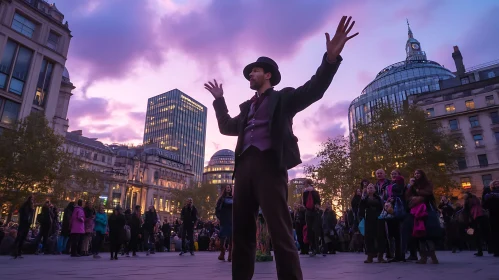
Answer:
303 179 322 257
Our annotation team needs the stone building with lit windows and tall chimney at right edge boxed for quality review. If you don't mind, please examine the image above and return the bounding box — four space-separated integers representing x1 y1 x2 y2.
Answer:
409 46 499 197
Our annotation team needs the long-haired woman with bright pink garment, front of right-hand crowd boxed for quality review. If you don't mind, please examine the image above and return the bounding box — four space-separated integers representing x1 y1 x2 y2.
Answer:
406 169 440 264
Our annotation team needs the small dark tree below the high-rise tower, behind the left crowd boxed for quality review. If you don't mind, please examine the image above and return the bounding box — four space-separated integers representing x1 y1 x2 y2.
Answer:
171 184 219 219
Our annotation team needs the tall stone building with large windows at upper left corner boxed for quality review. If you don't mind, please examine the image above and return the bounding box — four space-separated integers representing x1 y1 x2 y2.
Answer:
0 0 74 135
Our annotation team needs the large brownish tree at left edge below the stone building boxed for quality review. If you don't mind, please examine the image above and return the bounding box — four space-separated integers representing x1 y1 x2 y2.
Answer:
0 113 64 221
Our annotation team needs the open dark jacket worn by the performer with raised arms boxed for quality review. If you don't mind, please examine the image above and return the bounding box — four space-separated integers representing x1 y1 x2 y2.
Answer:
213 54 343 172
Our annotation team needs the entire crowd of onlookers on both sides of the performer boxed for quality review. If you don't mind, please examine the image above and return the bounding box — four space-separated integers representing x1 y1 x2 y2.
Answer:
0 170 499 264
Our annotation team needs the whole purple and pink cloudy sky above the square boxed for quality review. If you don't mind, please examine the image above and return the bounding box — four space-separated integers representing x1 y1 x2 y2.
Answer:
52 0 499 178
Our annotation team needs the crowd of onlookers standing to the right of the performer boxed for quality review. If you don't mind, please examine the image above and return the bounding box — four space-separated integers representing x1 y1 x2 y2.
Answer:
290 170 499 264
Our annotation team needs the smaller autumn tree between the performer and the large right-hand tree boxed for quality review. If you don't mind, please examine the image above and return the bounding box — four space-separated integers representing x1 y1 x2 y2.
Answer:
305 136 357 213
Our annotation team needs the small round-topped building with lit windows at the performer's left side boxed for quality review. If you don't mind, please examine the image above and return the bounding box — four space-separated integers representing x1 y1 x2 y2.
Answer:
203 149 236 190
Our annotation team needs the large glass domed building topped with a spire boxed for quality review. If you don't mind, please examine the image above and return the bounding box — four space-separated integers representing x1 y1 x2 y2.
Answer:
348 23 455 133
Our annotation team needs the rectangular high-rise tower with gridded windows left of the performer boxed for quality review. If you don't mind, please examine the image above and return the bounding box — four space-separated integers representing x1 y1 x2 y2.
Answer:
144 89 207 182
